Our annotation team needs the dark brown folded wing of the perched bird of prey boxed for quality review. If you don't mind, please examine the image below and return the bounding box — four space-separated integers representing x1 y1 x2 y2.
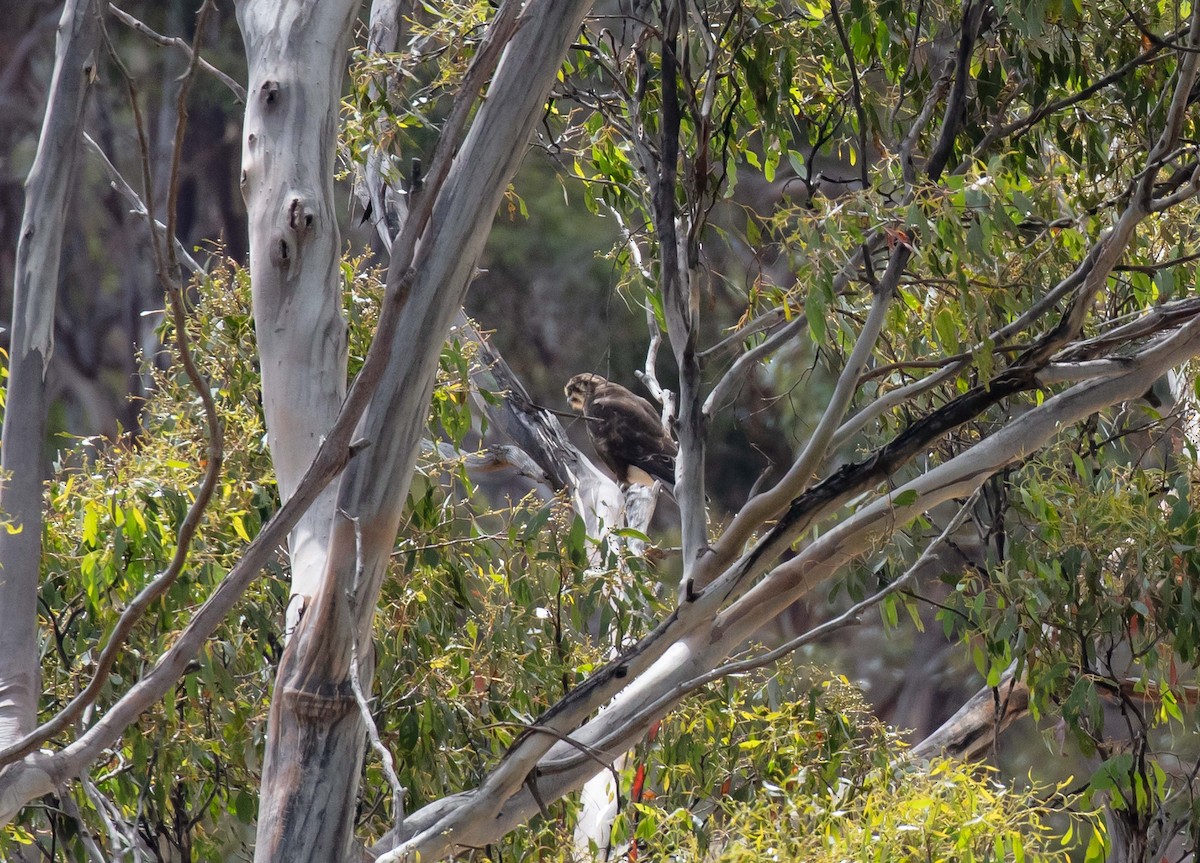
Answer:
587 386 677 484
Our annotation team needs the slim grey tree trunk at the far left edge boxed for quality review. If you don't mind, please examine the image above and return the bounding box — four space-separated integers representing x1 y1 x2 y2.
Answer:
0 0 100 749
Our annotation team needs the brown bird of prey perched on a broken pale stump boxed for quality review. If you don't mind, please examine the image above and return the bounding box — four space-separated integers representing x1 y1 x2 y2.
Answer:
565 374 678 485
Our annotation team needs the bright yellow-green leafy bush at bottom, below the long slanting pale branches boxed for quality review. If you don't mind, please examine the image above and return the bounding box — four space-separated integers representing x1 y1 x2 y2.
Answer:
623 678 1096 863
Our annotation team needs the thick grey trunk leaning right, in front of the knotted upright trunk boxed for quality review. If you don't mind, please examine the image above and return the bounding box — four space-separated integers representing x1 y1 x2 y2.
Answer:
244 0 590 863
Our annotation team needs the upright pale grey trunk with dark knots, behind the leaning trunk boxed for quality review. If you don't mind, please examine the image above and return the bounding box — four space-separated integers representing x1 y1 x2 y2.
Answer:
238 0 360 630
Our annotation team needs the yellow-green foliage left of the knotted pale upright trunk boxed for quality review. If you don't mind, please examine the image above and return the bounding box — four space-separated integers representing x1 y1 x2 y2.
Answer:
12 264 278 859
